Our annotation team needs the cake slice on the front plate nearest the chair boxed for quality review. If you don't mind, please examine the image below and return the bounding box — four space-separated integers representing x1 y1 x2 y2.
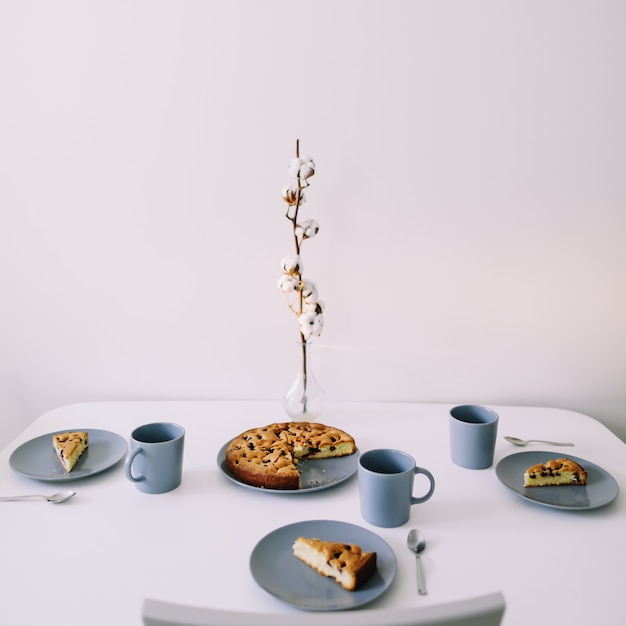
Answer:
293 537 376 591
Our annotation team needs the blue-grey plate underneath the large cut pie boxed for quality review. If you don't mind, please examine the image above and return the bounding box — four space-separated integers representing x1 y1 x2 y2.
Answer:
217 441 359 494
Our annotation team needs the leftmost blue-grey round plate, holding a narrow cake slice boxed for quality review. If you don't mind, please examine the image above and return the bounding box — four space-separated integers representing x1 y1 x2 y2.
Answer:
9 428 128 482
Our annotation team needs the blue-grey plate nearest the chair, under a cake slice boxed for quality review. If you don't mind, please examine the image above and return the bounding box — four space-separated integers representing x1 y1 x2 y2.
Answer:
250 520 397 611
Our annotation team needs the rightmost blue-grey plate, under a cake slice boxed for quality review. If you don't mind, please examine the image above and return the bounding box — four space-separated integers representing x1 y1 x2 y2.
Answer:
496 450 619 511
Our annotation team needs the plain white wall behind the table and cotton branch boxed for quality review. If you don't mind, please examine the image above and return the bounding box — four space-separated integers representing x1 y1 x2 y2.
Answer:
0 0 626 443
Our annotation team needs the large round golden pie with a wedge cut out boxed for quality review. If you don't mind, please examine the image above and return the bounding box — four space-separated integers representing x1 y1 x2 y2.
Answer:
226 422 356 489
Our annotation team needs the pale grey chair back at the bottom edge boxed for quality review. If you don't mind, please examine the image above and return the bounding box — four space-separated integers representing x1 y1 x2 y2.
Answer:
142 591 505 626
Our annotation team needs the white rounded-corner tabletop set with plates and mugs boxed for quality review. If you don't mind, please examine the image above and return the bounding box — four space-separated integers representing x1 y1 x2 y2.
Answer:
0 402 626 626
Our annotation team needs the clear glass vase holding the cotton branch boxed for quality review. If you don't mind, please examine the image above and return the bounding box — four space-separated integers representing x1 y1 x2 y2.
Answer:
283 343 326 422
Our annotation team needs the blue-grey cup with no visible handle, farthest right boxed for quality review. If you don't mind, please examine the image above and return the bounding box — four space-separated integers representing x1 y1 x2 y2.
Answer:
449 404 498 469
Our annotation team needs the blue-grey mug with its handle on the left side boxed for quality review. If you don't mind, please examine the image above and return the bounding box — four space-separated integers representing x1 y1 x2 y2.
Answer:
124 422 185 493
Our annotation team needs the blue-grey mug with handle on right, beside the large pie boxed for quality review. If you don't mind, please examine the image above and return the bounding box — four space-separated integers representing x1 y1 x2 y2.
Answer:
358 448 435 528
